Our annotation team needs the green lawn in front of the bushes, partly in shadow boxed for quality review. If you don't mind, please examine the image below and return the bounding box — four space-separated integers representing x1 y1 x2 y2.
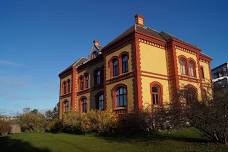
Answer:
0 129 228 152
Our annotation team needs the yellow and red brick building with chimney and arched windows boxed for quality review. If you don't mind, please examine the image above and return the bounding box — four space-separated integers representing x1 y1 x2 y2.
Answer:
59 15 212 118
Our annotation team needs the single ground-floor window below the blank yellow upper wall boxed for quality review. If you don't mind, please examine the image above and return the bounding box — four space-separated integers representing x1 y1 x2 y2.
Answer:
151 84 161 105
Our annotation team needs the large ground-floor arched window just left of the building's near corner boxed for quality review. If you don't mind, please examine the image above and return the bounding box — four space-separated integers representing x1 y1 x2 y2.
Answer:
115 87 127 107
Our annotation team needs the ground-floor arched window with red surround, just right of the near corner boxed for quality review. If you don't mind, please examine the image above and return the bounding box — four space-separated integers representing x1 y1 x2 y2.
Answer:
150 82 162 105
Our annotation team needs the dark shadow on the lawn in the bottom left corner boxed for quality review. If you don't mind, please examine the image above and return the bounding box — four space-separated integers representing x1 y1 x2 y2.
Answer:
0 136 50 152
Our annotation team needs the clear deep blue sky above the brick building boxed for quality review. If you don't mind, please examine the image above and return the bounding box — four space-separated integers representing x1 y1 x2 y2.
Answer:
0 0 228 114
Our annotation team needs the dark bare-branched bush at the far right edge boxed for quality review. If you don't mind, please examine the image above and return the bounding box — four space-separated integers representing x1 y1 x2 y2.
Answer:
188 90 228 144
